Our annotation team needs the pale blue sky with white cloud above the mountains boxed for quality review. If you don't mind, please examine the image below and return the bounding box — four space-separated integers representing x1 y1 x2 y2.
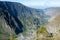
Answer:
1 0 60 8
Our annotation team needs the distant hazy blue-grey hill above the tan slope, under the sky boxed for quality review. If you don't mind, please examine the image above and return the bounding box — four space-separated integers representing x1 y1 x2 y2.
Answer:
45 7 60 16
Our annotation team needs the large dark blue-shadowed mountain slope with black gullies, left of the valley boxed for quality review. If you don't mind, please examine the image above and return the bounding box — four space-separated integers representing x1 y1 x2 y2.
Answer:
0 1 49 40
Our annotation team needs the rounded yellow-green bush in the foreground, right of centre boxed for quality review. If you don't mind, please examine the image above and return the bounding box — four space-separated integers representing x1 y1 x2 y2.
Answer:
36 26 49 40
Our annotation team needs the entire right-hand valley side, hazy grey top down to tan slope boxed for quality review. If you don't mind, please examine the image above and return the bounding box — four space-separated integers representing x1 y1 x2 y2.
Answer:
44 7 60 40
